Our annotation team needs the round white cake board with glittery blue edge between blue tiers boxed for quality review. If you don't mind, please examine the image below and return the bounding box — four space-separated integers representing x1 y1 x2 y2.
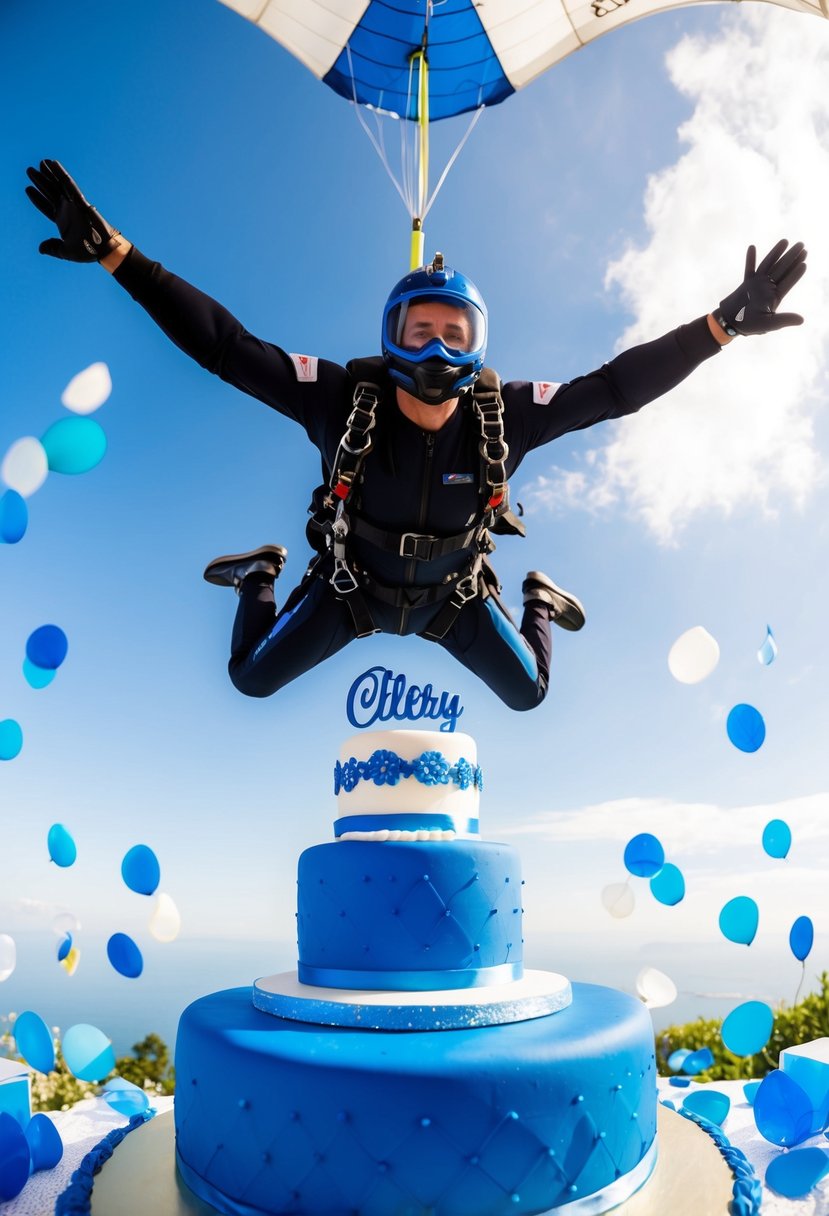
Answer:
253 972 573 1030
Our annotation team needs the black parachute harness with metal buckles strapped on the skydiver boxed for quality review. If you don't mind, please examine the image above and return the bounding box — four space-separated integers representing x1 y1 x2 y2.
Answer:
304 359 525 641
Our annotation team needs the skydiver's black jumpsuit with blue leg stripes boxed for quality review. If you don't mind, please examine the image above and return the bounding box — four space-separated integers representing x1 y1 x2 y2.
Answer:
114 248 720 709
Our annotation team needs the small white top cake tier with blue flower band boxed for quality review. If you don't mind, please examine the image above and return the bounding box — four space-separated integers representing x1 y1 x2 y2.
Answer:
334 731 481 835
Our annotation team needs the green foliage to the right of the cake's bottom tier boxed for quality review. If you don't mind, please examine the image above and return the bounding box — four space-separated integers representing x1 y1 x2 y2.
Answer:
656 972 829 1081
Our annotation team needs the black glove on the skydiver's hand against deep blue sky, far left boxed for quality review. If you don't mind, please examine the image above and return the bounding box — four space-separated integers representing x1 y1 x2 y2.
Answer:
26 161 120 261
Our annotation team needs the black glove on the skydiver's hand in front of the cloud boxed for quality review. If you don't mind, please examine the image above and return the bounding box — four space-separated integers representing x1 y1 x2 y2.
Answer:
712 241 806 338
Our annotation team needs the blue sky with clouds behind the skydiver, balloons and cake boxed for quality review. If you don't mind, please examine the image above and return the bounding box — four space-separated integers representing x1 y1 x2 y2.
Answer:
0 0 829 1031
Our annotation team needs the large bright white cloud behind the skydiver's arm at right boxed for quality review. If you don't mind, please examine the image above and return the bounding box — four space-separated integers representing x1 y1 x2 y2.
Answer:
521 6 829 544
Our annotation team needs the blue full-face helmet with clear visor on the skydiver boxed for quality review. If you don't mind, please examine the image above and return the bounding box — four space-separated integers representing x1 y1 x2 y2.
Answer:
382 253 486 405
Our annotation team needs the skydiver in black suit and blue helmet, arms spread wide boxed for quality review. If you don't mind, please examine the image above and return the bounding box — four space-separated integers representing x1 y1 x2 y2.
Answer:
26 161 806 710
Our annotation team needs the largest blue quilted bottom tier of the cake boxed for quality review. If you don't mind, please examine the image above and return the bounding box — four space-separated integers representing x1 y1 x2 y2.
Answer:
175 984 656 1216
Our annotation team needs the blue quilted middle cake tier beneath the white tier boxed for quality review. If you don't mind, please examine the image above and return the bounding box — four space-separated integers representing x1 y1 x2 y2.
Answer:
297 840 523 991
